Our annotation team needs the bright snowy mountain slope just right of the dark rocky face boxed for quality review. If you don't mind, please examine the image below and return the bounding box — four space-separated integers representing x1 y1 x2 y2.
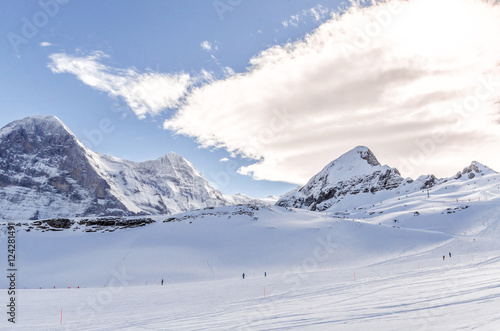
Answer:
93 153 228 214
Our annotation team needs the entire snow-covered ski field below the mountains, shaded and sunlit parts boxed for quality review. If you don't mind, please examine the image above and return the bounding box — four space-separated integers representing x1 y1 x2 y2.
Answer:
0 178 500 330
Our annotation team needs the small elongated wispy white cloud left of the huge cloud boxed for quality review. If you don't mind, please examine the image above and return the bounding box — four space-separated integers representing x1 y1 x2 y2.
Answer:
48 52 192 118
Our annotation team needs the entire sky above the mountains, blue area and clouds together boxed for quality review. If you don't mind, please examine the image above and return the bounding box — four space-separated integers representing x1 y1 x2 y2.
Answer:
0 0 500 197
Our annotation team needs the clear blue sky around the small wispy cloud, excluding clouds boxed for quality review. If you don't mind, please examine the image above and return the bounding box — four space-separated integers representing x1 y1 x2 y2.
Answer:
0 1 336 196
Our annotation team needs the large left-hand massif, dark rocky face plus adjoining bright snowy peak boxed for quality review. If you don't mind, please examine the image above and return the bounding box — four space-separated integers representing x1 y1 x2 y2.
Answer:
0 116 228 219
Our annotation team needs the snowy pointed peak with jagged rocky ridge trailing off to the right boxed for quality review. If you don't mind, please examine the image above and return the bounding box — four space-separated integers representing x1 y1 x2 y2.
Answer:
276 146 497 211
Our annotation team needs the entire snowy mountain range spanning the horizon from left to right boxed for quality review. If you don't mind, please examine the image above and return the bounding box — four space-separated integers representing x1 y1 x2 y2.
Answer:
0 116 497 220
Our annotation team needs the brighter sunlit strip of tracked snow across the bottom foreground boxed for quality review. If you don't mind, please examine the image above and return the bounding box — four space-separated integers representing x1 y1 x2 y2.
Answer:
3 256 500 330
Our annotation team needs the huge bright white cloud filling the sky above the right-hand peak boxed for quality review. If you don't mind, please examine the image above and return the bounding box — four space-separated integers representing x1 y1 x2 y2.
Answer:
164 0 500 184
